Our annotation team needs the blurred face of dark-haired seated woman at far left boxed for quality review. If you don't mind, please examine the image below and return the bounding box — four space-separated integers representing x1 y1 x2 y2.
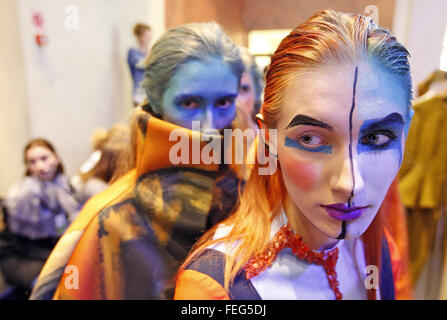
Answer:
26 146 60 181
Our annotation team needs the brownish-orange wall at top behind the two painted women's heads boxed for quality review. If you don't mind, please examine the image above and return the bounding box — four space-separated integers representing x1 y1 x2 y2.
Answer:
166 0 395 46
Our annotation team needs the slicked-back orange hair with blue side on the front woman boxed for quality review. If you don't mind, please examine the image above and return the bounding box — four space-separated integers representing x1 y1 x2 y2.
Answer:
180 10 412 299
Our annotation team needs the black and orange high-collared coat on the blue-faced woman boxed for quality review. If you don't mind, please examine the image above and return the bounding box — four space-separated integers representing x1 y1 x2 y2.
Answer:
31 114 242 299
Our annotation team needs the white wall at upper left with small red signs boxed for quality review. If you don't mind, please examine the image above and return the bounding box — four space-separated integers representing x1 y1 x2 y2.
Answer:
0 0 165 194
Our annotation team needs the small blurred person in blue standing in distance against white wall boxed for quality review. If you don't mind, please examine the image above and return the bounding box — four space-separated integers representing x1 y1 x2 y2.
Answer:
127 23 152 106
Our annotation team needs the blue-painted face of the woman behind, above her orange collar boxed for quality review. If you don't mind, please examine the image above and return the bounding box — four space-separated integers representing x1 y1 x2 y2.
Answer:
162 60 239 131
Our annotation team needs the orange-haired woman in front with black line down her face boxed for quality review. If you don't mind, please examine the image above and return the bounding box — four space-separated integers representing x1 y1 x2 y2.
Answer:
175 10 413 299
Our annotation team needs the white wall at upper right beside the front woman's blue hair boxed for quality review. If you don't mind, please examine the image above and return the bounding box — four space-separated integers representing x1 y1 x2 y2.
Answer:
393 0 447 93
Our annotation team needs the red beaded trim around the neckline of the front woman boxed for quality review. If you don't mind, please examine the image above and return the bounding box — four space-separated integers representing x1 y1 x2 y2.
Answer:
244 223 343 300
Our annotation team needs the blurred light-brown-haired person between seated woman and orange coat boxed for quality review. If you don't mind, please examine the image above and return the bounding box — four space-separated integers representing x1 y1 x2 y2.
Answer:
71 124 130 205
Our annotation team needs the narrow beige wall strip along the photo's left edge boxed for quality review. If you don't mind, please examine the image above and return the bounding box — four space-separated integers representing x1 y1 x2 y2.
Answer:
0 0 29 196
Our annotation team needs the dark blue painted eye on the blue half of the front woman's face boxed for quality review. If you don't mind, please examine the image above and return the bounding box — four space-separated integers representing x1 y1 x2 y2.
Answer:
357 113 405 165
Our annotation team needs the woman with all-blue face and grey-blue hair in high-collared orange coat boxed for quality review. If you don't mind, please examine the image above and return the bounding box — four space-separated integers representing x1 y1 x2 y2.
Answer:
32 23 243 299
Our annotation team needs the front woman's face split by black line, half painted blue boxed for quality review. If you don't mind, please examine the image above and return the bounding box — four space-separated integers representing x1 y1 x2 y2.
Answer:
277 62 409 239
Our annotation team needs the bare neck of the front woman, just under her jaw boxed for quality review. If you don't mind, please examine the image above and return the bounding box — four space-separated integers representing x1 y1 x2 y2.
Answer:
283 196 339 251
